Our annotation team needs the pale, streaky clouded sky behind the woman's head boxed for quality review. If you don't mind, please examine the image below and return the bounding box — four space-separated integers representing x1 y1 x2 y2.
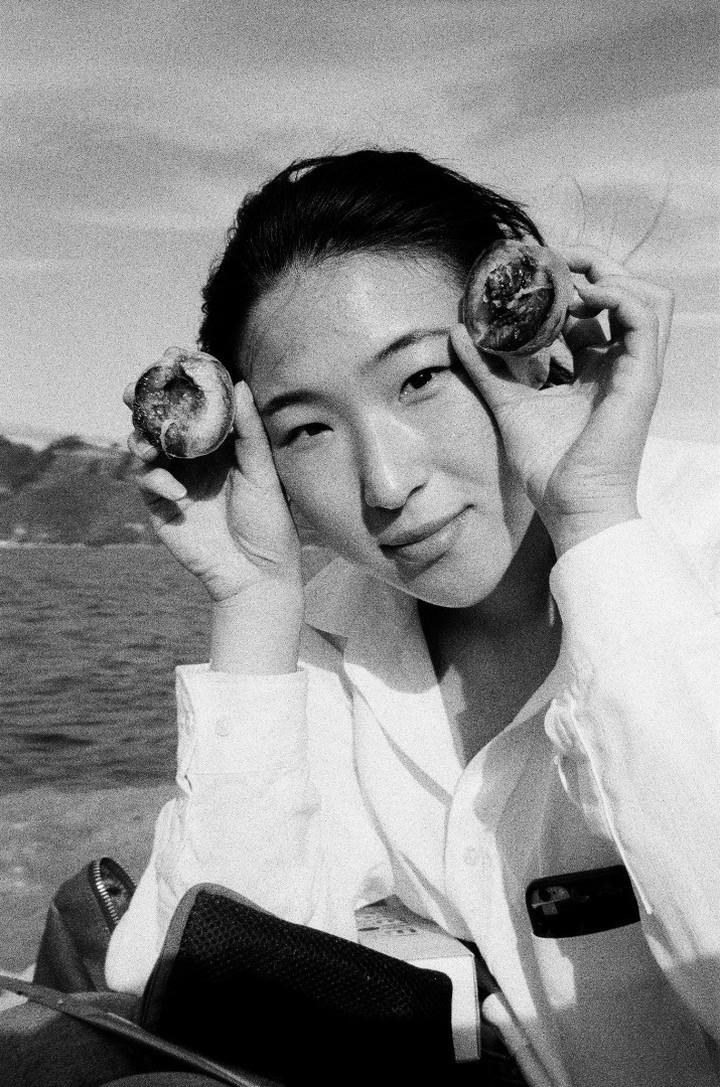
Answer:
0 0 720 441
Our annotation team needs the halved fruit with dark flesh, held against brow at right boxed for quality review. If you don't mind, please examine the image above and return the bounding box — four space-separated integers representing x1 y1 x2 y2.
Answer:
461 238 574 359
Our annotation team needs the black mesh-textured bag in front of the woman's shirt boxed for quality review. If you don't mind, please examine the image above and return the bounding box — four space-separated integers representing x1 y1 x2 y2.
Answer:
140 884 455 1087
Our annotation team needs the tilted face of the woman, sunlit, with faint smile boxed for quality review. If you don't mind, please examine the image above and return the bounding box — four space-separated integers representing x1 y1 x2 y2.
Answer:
238 254 539 607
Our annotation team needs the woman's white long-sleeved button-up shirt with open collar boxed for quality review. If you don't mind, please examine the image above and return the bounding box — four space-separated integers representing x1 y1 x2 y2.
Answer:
107 442 720 1087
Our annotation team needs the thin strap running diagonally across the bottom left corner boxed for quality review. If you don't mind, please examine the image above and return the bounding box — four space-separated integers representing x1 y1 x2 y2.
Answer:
0 974 277 1087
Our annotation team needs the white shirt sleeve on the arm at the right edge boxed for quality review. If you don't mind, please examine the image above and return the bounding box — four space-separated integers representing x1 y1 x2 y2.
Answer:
545 520 720 1037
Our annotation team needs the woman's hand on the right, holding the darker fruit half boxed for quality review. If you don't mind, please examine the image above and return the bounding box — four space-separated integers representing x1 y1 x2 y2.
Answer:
450 248 672 557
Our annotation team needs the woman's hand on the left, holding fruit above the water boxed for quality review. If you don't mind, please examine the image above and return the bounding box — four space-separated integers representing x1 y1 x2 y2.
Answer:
123 382 301 605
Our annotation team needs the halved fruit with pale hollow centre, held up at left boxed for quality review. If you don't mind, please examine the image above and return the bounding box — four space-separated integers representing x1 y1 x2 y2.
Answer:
133 347 235 460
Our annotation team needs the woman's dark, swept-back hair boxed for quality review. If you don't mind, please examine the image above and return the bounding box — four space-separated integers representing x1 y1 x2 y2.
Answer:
198 149 542 370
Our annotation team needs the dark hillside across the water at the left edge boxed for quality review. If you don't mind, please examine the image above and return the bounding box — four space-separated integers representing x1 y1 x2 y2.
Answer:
0 436 156 546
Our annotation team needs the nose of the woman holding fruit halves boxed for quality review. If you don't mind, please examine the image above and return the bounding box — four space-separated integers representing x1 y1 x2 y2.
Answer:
361 420 427 510
